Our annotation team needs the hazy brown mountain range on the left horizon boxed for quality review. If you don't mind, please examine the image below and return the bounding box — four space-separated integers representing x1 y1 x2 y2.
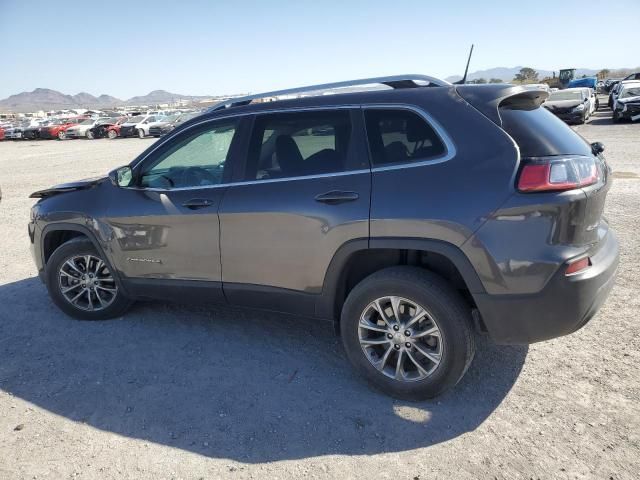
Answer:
0 88 211 112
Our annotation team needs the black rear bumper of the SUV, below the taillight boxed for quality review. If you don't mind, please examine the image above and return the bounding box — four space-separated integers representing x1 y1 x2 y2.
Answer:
474 230 618 344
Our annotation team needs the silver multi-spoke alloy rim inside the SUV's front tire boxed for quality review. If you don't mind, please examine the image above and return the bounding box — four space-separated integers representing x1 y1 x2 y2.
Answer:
58 255 118 311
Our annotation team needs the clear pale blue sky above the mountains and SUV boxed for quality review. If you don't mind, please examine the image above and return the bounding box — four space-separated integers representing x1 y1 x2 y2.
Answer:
0 0 640 98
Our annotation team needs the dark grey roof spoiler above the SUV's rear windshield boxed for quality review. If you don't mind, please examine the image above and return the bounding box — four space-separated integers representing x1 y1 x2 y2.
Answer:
456 84 549 126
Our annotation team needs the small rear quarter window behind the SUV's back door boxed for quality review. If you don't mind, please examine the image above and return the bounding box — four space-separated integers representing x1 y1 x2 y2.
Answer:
364 109 446 166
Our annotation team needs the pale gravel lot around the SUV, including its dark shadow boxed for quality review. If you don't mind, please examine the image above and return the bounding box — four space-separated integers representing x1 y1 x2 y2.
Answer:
0 114 640 480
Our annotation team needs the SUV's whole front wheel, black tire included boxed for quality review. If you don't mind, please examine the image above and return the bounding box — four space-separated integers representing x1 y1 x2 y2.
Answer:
45 237 132 320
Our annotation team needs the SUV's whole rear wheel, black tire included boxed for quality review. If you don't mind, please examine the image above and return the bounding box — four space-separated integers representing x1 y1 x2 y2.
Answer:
340 266 475 401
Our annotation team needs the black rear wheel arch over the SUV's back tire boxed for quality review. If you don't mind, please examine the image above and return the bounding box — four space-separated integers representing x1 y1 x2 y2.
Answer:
315 238 485 322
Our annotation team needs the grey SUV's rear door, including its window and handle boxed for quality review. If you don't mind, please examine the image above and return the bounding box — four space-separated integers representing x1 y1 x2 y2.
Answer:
219 108 371 314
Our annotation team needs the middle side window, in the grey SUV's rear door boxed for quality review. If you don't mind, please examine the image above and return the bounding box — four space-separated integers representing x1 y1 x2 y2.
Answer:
247 110 351 180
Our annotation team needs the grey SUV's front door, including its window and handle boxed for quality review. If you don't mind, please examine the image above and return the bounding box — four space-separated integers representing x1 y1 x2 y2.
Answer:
108 120 237 300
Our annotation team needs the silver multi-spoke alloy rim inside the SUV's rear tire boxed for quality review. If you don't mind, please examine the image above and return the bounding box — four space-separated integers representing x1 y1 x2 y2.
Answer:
358 296 444 382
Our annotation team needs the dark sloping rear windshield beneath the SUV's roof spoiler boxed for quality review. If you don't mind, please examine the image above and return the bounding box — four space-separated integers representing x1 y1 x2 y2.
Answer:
500 105 591 157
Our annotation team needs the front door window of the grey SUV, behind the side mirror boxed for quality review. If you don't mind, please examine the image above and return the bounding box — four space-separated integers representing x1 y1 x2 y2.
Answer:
140 121 236 189
